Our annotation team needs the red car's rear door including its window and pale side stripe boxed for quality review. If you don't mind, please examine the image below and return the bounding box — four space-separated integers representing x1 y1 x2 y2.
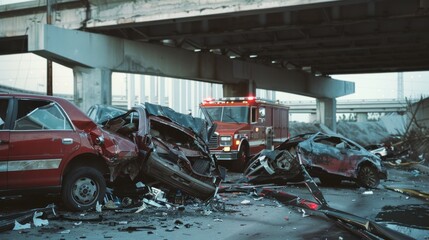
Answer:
8 99 80 189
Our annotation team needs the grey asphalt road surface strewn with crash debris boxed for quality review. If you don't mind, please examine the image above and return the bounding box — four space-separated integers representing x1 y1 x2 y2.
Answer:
0 168 429 240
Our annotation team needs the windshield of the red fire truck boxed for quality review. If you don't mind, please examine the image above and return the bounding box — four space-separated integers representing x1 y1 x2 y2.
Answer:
204 106 249 123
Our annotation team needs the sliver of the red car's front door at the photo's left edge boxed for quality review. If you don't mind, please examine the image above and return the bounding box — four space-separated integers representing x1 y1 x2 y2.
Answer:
0 98 9 191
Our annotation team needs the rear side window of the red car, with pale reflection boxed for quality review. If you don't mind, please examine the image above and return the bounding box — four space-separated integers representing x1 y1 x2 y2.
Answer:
13 100 72 130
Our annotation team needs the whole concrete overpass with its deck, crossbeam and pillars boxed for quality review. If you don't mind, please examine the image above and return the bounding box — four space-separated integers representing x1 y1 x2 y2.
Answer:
0 0 429 128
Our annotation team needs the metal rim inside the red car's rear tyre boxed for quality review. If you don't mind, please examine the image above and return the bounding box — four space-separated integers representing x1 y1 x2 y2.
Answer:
72 177 99 205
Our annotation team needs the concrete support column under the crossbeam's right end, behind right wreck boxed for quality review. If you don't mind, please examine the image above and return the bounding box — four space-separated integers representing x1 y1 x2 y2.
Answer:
316 98 337 132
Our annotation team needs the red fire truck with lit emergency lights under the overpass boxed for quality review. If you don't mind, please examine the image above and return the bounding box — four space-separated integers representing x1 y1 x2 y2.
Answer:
200 97 289 171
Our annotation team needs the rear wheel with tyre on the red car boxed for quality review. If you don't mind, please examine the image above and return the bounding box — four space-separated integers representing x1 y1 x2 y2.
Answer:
62 167 106 211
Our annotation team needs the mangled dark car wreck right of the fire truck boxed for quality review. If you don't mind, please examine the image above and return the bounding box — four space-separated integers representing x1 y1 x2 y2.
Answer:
245 132 387 188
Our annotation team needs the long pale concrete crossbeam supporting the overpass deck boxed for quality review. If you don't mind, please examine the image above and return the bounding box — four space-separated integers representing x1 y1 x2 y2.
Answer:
28 24 355 98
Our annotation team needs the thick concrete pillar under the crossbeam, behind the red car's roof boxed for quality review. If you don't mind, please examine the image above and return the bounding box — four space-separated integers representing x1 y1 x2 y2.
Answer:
73 67 112 112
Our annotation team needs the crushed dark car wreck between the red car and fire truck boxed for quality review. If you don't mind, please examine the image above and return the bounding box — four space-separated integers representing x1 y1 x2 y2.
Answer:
98 103 221 200
